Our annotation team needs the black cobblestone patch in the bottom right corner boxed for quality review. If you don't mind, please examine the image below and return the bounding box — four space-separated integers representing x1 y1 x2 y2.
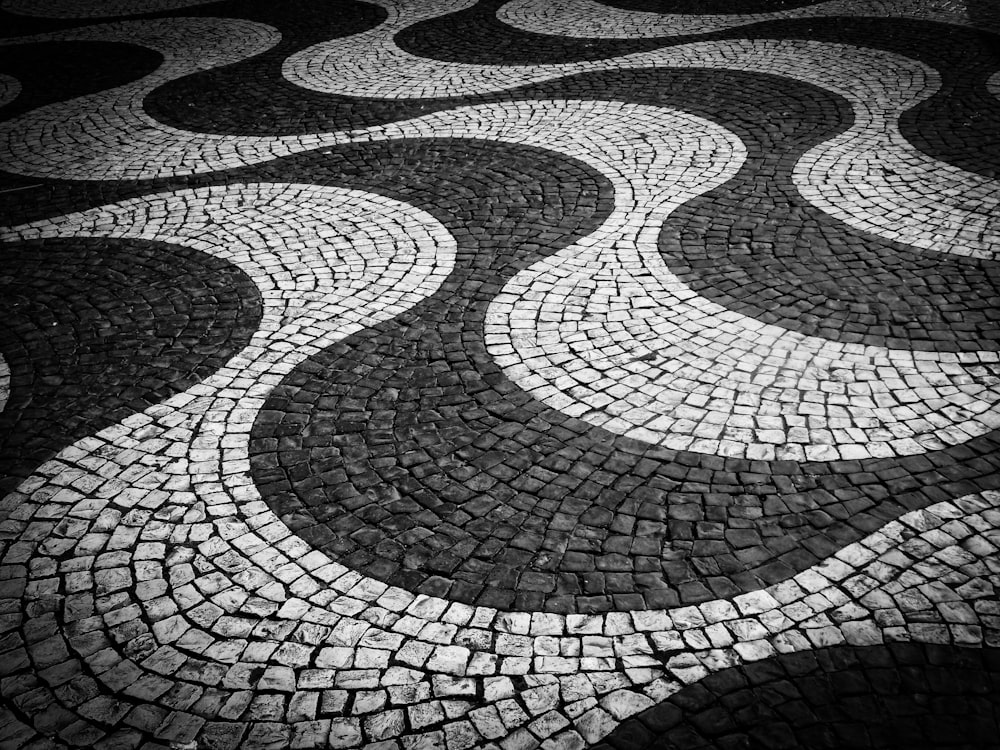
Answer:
594 643 1000 750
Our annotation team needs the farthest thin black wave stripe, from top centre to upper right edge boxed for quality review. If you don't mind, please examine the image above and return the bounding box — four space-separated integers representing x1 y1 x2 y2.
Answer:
396 10 1000 177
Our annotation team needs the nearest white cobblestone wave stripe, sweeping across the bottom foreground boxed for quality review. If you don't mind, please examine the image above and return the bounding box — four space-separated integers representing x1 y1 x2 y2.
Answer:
0 185 1000 747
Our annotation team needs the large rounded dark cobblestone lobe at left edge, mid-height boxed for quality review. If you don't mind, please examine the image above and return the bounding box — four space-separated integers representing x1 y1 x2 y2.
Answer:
0 238 261 494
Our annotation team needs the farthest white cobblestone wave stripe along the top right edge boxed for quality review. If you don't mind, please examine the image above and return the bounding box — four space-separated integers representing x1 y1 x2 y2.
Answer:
497 0 1000 39
